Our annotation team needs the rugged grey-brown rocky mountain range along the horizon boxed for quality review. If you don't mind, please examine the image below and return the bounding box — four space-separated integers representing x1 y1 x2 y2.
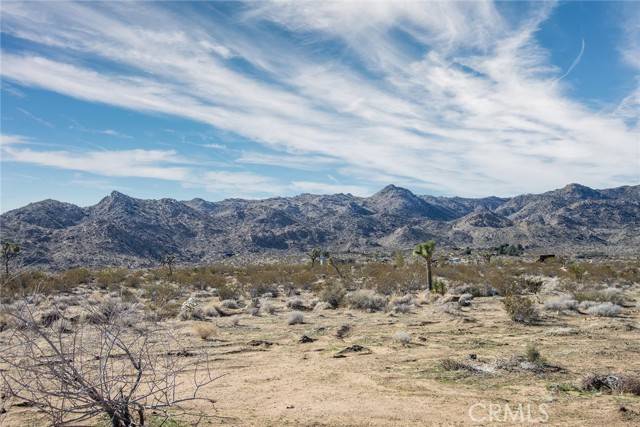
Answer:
0 184 640 269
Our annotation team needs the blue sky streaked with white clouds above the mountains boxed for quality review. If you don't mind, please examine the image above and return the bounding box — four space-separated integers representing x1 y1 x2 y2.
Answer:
0 1 640 212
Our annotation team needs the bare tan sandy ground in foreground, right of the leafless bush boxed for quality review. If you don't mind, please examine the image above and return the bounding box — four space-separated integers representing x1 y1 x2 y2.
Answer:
1 295 640 426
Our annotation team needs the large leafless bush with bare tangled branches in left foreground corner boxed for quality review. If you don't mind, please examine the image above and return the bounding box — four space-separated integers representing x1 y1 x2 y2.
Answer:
0 305 216 427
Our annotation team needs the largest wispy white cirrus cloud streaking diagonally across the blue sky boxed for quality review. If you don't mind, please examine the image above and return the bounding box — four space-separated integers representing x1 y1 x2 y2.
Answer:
2 2 639 195
